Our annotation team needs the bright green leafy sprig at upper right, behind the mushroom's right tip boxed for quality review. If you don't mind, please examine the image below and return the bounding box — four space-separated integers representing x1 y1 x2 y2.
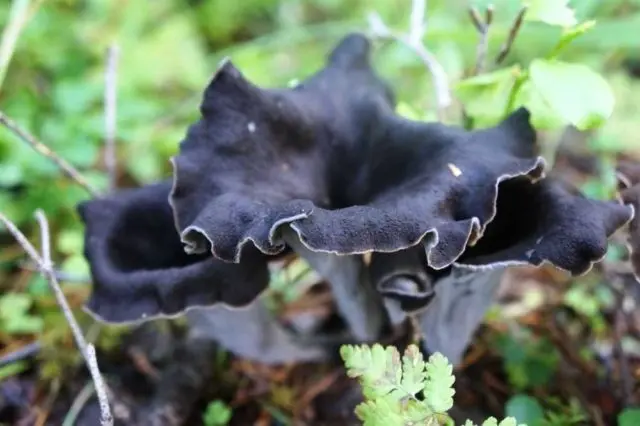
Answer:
455 0 614 130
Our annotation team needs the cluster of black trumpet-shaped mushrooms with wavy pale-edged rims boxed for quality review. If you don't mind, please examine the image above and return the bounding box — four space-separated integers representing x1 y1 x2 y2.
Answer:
80 34 633 362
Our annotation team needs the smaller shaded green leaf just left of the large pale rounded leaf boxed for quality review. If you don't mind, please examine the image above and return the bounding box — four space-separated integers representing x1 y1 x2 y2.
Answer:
454 65 521 127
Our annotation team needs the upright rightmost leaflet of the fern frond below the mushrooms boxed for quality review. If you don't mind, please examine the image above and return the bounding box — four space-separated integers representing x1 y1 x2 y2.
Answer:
424 352 456 413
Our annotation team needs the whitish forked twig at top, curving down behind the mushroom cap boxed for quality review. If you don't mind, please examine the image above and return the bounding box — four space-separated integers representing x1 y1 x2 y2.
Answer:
368 0 452 121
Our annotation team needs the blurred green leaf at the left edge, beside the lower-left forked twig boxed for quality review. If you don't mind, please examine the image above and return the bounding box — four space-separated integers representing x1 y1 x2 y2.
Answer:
0 293 44 334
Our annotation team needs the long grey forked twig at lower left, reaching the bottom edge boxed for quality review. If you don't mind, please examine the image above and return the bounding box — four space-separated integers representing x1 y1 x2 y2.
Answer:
0 210 113 426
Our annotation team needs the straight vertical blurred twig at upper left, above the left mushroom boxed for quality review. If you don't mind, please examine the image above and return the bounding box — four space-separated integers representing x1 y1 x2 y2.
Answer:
104 45 120 190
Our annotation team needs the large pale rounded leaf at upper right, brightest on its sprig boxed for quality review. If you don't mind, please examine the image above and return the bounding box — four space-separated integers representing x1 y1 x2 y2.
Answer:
530 59 614 130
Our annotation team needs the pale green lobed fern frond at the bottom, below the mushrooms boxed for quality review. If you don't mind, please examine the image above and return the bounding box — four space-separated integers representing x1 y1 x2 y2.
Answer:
340 344 524 426
